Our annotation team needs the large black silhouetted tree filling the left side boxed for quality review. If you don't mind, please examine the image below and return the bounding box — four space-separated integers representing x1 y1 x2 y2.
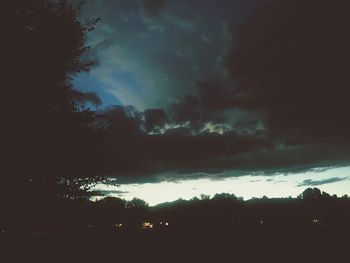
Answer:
0 0 99 207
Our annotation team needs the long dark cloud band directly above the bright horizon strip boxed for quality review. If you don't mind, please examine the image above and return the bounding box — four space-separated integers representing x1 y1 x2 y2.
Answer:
89 106 350 185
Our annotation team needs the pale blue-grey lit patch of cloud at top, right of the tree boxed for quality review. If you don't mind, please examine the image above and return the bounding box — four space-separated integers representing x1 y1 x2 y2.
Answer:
73 0 260 110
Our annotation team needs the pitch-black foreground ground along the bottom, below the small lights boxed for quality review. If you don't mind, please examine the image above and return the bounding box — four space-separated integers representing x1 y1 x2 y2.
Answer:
0 227 350 262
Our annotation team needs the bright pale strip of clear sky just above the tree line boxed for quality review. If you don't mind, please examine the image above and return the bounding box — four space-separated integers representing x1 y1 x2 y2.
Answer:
93 166 350 206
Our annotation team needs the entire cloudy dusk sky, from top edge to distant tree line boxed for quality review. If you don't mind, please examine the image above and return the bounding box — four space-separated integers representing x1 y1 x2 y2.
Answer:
69 0 350 204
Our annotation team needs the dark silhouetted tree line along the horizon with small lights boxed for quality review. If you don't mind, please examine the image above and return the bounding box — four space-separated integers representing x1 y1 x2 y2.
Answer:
0 188 350 234
